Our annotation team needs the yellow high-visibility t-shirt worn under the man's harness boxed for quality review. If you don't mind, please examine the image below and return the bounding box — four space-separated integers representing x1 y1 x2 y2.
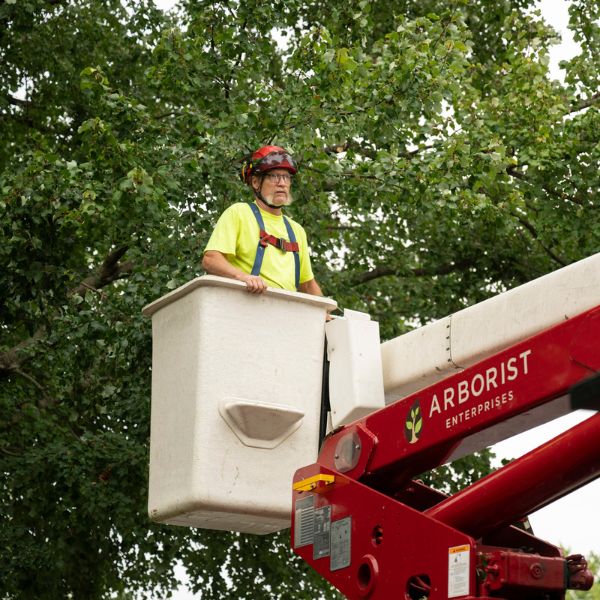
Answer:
204 202 314 291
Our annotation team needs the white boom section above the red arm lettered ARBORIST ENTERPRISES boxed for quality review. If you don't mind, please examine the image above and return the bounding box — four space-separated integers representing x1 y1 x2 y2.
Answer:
381 253 600 404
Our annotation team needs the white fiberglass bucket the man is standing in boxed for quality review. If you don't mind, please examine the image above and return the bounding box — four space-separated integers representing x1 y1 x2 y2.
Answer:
144 275 336 534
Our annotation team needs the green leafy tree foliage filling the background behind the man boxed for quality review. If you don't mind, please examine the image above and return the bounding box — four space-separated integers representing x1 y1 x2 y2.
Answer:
0 0 600 599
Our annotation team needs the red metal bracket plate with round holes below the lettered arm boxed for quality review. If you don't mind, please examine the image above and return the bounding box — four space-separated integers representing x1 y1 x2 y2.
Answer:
292 465 476 600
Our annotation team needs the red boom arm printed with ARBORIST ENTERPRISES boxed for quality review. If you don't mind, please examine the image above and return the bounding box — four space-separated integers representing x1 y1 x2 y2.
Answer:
318 307 600 489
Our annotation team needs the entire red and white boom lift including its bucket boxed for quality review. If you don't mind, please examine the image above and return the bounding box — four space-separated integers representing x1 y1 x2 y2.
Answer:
144 254 600 600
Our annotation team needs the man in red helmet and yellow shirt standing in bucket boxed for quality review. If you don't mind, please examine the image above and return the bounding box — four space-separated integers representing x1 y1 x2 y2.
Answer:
202 146 323 296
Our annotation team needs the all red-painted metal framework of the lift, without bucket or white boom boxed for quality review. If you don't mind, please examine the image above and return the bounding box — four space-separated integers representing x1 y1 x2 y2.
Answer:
292 307 600 600
